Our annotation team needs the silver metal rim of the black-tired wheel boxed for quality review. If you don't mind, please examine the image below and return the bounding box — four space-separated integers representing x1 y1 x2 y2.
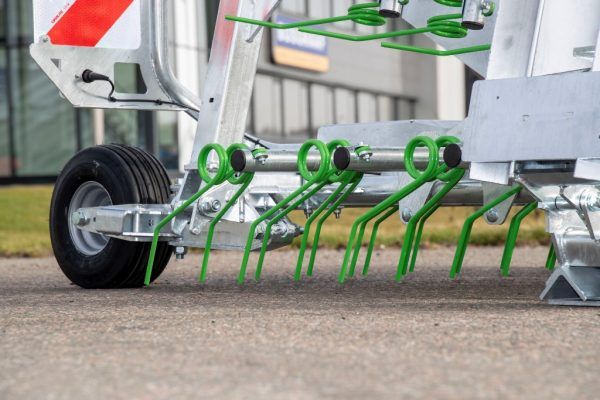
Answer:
68 181 112 256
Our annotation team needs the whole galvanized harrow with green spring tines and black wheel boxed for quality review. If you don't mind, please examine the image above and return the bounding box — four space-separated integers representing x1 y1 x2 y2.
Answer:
31 0 600 305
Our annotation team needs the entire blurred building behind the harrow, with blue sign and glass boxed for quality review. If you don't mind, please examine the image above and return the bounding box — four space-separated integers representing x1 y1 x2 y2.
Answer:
0 0 472 184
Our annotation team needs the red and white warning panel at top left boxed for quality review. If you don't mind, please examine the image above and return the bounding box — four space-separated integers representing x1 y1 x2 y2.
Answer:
33 0 143 50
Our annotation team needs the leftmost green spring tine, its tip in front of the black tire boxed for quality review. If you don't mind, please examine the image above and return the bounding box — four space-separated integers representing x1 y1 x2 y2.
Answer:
144 144 229 286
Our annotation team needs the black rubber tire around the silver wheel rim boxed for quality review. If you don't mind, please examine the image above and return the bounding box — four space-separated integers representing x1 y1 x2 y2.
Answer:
50 145 172 289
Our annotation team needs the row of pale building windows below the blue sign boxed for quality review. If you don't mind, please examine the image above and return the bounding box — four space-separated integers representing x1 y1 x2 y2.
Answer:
248 71 416 143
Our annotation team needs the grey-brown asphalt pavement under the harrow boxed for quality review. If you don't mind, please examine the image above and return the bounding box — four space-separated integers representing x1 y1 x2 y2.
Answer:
0 248 600 400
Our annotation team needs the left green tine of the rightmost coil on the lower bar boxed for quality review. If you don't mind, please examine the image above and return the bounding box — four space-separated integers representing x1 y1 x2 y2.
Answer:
338 136 439 283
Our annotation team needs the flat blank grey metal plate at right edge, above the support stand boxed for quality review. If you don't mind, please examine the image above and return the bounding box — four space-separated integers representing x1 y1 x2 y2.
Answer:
464 72 600 162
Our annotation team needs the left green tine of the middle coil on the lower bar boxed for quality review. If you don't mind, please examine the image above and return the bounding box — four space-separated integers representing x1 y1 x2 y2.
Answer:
238 140 331 285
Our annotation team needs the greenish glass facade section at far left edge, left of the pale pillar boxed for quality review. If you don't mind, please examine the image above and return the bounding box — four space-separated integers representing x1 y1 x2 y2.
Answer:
0 0 86 178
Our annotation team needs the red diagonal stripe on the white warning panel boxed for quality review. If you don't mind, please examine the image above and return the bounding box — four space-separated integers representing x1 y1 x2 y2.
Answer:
48 0 133 47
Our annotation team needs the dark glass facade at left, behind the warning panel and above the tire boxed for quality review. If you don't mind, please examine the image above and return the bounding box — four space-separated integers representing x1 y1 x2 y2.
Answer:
0 0 178 183
